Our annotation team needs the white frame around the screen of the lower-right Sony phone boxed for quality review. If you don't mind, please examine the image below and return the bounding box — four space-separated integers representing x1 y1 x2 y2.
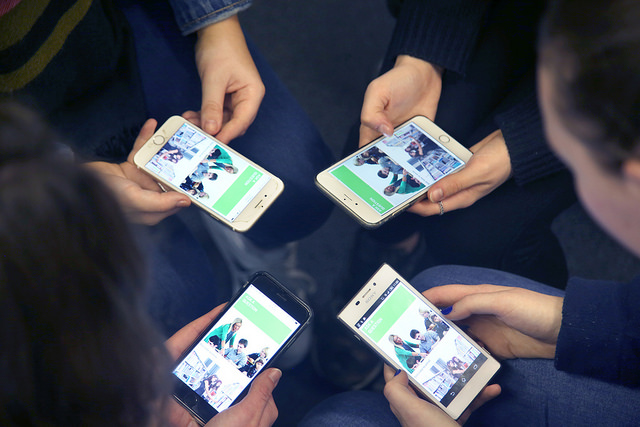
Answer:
338 264 500 419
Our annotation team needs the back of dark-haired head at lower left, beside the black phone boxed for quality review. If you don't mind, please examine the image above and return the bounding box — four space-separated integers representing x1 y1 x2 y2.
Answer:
0 104 169 425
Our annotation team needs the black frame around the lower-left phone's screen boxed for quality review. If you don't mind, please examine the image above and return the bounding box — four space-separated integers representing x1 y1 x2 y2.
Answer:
171 271 313 425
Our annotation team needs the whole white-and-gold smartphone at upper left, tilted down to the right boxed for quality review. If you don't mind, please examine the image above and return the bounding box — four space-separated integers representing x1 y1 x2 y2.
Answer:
134 116 284 231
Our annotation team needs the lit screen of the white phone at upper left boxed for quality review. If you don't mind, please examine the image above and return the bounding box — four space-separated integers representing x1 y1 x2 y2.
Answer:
145 123 270 222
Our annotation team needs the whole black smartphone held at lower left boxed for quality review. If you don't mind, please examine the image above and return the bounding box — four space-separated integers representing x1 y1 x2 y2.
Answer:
173 272 313 425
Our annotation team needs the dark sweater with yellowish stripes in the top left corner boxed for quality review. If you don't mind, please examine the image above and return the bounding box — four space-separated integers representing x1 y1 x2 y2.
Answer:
0 0 145 160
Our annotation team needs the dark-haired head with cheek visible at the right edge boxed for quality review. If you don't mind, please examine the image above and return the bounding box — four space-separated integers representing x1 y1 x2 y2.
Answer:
538 0 640 255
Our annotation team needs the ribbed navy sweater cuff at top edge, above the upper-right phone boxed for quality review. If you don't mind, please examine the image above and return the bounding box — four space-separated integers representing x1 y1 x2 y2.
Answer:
387 0 487 75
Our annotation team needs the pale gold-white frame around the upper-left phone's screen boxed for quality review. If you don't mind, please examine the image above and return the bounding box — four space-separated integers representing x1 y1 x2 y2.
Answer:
133 116 284 232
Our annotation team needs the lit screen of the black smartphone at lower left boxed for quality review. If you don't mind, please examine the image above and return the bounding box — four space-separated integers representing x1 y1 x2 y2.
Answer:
173 284 301 412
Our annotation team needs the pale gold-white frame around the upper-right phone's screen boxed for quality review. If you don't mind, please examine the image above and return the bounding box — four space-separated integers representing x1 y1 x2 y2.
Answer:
315 116 473 228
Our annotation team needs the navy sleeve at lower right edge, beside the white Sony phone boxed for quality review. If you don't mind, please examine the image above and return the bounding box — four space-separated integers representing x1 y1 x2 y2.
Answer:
555 276 640 386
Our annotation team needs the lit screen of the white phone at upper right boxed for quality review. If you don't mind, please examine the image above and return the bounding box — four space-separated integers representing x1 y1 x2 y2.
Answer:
329 122 464 215
